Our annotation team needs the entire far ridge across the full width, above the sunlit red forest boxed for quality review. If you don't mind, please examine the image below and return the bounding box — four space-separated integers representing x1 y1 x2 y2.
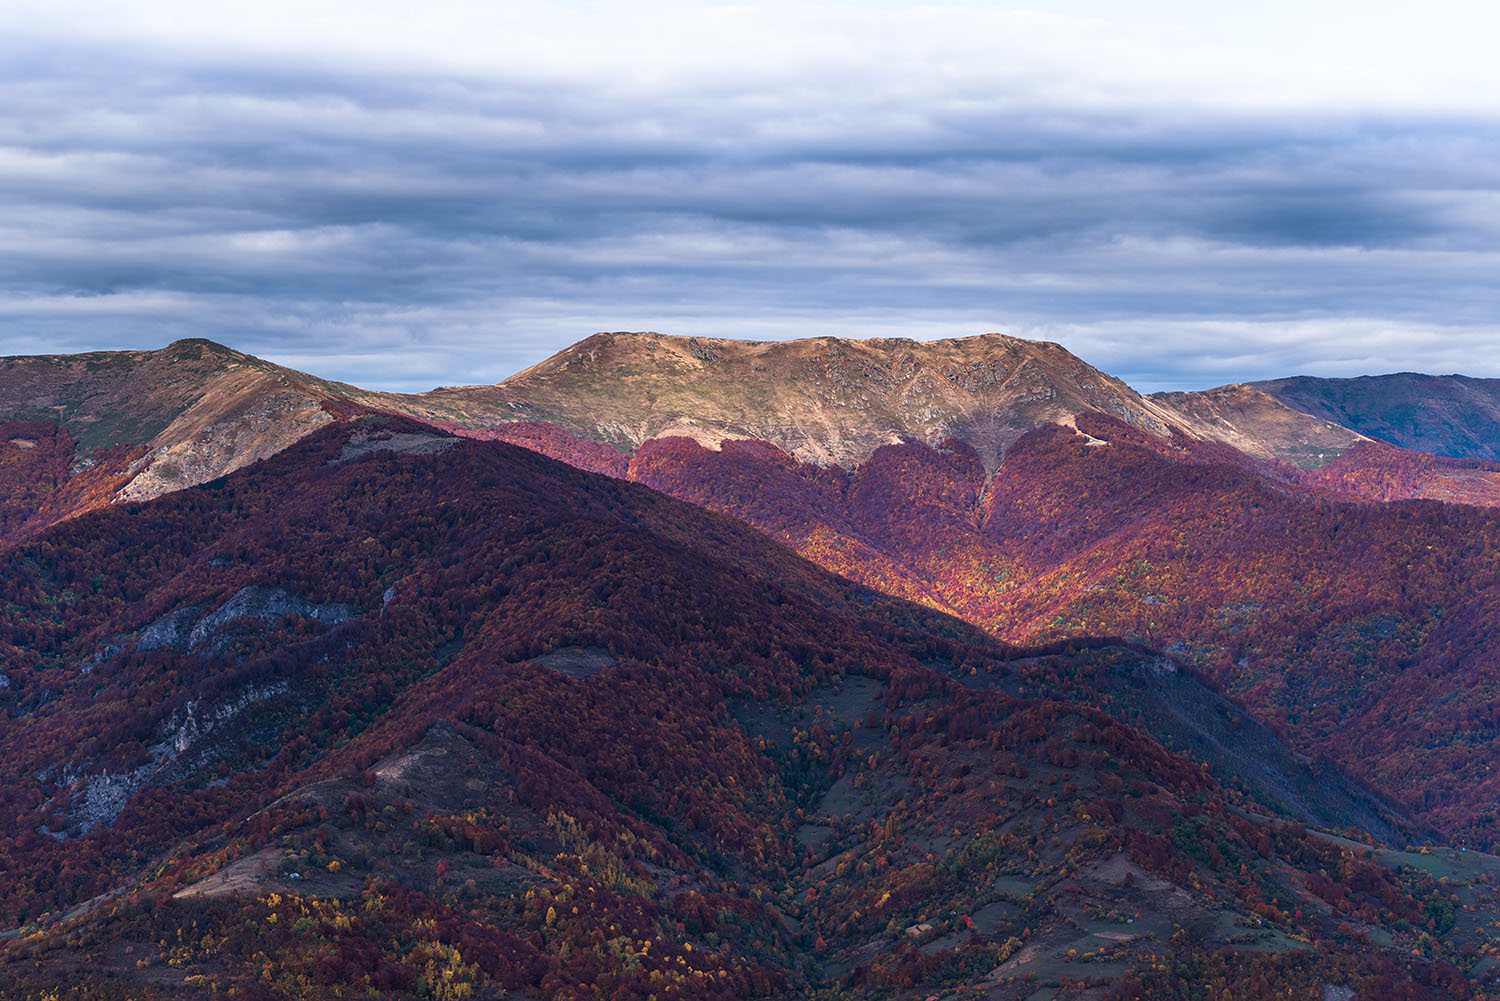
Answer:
0 332 1500 542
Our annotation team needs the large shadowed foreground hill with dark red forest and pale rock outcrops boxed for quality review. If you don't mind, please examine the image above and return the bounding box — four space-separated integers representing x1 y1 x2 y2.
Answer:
0 419 1491 999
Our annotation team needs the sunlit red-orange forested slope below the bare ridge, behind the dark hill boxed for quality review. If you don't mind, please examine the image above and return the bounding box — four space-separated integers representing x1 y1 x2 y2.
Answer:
489 414 1500 846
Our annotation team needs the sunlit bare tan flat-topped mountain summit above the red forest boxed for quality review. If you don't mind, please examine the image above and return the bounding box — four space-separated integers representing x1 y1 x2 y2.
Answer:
405 333 1362 471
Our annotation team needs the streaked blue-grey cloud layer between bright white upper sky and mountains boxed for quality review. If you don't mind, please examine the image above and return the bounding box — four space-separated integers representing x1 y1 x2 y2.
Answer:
0 35 1500 389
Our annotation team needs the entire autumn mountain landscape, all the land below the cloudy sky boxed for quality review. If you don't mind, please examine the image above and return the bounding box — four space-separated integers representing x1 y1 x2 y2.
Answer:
0 333 1500 1001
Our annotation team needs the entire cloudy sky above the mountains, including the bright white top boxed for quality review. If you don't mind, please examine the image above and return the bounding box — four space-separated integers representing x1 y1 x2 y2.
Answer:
0 0 1500 392
